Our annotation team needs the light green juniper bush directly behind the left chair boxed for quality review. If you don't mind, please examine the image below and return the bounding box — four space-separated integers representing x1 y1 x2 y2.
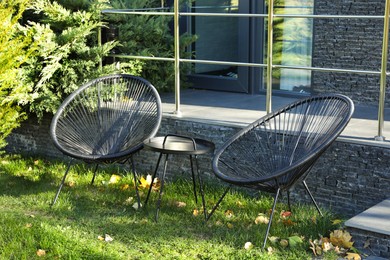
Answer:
22 0 140 118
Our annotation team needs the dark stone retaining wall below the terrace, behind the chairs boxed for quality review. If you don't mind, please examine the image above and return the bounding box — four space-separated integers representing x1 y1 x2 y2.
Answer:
7 117 390 217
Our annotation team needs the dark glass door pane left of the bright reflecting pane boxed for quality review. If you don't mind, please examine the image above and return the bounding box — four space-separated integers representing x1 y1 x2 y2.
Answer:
189 0 250 93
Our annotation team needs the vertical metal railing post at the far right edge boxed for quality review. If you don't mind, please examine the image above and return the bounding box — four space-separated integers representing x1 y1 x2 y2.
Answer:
375 0 390 141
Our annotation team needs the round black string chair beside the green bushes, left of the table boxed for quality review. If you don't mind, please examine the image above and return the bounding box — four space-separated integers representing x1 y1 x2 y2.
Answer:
50 74 162 205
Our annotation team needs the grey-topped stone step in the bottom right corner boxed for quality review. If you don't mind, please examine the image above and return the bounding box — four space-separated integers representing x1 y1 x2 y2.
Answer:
345 199 390 259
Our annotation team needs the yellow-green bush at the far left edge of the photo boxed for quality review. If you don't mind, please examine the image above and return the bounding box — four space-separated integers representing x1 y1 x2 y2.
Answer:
0 0 34 148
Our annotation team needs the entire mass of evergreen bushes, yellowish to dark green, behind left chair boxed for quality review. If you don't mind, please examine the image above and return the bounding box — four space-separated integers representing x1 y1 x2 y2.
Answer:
0 0 195 149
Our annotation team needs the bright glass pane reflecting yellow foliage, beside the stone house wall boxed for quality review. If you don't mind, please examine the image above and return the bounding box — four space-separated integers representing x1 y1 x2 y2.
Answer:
272 0 314 93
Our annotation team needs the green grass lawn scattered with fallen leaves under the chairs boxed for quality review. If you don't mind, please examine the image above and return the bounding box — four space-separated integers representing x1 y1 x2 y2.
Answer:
0 156 354 259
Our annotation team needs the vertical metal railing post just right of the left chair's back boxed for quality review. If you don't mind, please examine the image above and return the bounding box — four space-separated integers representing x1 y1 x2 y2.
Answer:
173 0 181 117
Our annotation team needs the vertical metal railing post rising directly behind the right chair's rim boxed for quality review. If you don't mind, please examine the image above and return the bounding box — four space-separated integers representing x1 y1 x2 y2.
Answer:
265 0 274 113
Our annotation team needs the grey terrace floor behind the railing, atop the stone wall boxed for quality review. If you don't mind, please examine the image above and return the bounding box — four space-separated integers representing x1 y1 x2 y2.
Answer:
161 89 390 148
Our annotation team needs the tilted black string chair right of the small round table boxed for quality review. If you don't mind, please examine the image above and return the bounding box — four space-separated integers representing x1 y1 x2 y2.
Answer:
208 94 354 248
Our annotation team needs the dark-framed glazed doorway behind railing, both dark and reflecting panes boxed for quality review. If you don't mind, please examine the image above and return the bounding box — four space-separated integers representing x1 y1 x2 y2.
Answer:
189 0 314 94
